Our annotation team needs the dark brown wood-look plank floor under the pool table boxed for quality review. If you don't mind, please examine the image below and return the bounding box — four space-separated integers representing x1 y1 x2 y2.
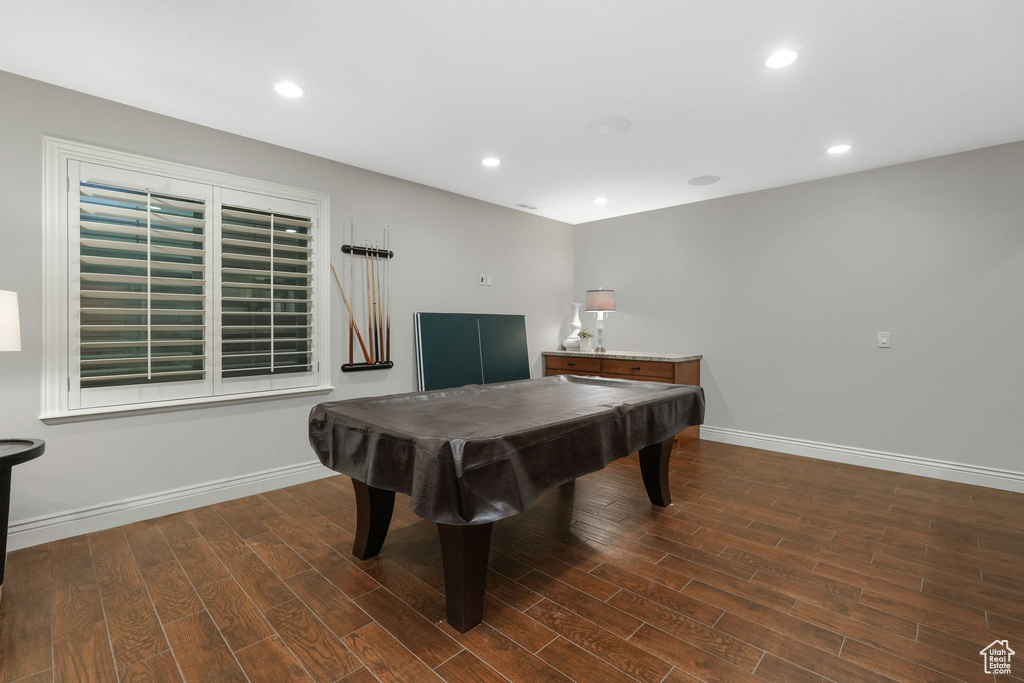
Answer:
0 441 1024 683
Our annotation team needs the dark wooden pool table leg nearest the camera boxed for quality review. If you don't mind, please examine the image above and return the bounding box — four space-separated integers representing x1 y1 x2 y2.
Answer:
437 523 494 633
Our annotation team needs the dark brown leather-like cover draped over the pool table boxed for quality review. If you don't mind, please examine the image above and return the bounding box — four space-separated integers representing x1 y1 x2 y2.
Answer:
309 375 705 524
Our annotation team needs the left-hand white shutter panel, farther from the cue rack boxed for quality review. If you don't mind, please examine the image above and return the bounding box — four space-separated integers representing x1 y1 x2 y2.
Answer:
68 162 213 408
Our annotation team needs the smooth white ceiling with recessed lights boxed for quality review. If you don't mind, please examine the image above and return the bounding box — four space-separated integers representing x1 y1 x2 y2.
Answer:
0 0 1024 223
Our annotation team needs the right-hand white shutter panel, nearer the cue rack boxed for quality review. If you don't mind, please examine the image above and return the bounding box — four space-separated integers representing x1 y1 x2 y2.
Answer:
217 189 318 392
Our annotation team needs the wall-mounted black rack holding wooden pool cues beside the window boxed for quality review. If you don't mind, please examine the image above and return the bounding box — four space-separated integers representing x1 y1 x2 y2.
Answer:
331 223 394 373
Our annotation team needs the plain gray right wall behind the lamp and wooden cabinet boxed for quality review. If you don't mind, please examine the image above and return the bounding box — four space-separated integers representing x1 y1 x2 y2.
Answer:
574 142 1024 472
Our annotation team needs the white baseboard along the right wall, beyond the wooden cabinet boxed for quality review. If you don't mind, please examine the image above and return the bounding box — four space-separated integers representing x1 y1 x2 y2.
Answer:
700 425 1024 493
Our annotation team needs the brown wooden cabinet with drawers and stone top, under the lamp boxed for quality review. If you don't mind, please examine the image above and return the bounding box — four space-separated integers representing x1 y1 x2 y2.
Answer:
542 351 703 446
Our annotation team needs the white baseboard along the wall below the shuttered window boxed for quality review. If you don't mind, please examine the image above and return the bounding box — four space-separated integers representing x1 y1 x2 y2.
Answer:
7 462 334 551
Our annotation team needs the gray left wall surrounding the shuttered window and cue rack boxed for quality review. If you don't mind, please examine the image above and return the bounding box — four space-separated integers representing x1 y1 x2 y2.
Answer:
0 72 572 540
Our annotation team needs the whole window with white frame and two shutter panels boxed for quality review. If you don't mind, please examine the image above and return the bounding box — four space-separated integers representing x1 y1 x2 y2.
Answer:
42 138 331 421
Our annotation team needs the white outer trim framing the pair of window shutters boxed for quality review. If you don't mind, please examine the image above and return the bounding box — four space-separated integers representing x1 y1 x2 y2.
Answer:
39 136 334 424
